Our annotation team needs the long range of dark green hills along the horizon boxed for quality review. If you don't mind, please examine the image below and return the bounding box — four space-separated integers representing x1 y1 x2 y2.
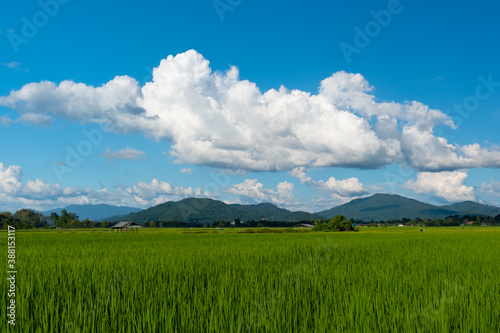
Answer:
42 194 500 224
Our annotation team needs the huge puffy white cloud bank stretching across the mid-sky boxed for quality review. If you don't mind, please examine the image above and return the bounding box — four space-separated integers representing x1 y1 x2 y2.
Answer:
0 50 500 171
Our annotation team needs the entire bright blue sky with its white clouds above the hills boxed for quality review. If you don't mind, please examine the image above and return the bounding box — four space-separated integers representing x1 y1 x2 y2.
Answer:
0 0 500 211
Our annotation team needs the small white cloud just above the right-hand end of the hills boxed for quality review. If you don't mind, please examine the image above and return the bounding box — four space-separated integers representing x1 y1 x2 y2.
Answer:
404 170 476 202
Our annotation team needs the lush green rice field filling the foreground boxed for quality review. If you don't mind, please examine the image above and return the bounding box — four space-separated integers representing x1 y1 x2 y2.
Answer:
1 227 500 332
